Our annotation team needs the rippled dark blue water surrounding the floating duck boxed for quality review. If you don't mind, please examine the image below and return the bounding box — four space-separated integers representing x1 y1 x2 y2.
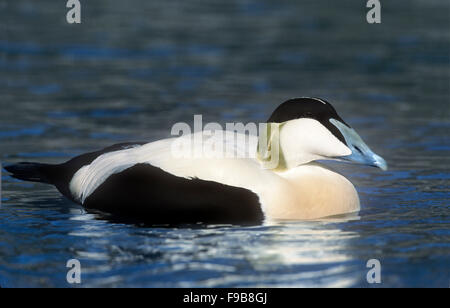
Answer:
0 0 450 287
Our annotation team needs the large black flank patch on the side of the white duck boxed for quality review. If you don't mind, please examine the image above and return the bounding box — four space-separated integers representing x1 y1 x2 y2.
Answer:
84 164 264 224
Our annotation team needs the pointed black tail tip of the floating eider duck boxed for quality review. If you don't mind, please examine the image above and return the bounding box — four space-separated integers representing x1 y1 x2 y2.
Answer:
4 162 55 184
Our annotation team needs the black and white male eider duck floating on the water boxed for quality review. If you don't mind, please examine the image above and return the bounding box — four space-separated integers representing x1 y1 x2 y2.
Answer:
5 97 387 224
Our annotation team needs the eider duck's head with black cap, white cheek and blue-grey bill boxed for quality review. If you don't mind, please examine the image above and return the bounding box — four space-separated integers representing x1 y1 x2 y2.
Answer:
258 97 387 170
